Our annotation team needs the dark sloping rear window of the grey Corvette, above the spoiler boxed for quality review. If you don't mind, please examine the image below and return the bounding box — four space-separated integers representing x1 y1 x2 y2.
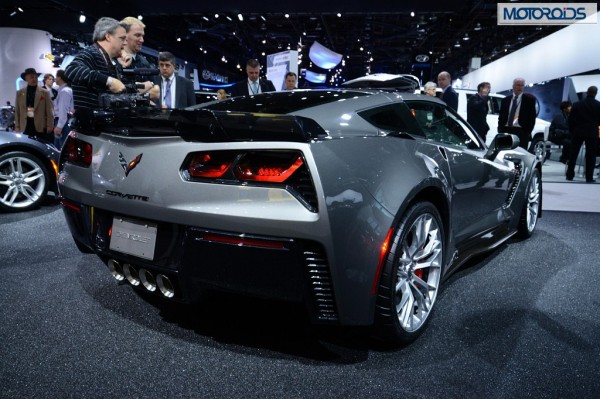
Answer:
197 90 369 114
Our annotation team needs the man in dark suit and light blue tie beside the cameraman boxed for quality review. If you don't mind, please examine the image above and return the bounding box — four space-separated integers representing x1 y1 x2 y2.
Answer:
154 51 196 108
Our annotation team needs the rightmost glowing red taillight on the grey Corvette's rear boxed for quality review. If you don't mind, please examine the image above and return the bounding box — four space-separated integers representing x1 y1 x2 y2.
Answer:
234 152 304 183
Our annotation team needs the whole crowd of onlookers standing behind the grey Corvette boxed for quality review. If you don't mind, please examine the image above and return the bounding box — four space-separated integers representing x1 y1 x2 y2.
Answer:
10 17 600 183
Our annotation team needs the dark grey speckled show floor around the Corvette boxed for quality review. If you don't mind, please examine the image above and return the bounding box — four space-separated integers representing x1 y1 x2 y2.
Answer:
0 168 600 399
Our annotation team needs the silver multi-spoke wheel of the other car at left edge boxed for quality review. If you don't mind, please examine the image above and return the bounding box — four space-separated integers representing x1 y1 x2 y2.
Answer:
0 151 49 212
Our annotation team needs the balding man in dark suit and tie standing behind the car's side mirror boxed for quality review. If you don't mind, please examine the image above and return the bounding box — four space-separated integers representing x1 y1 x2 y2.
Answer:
498 78 537 149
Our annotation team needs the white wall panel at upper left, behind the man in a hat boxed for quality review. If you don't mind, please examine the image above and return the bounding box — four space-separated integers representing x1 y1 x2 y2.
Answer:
0 28 56 106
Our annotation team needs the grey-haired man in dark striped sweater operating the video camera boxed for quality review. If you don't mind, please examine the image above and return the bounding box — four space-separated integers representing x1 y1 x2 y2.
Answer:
65 17 158 115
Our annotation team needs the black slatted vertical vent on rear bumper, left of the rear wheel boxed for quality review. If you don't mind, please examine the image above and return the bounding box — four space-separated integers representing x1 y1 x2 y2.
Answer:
304 245 338 322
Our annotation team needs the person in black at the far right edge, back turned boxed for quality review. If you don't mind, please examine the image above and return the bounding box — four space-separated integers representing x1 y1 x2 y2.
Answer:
567 86 600 183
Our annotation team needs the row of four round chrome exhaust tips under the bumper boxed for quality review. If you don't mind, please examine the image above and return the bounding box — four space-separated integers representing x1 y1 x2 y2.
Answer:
107 259 175 298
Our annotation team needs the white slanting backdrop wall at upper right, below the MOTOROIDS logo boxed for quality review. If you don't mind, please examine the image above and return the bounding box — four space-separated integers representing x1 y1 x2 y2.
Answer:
462 11 600 92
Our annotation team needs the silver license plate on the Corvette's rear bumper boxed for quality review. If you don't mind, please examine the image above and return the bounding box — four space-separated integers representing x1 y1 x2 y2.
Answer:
110 216 157 260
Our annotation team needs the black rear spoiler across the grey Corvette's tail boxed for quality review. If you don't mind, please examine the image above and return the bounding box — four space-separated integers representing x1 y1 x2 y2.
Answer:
75 107 328 142
